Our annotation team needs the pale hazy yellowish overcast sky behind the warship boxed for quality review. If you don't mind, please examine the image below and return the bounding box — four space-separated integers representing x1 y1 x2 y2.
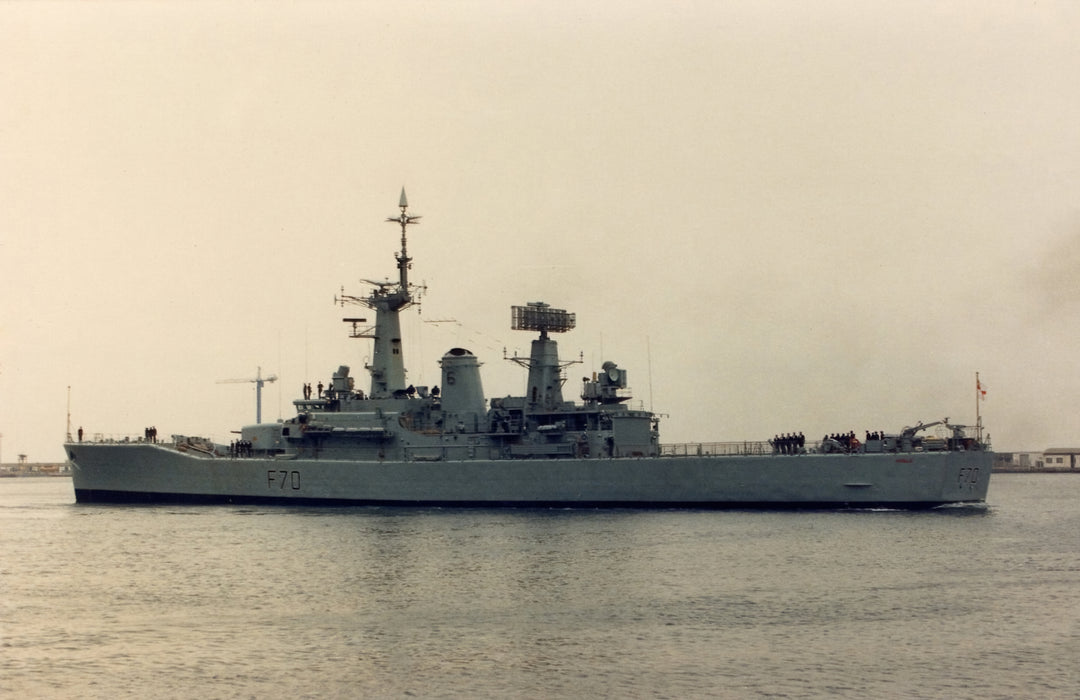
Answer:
0 0 1080 462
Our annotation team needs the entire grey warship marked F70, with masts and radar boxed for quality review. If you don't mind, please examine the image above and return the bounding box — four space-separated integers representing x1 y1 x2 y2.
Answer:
64 189 993 509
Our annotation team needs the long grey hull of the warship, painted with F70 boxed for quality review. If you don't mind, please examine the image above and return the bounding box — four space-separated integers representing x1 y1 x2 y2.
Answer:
66 443 991 508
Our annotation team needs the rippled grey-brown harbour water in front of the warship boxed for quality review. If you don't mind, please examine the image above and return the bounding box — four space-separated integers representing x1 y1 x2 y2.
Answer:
0 474 1080 698
